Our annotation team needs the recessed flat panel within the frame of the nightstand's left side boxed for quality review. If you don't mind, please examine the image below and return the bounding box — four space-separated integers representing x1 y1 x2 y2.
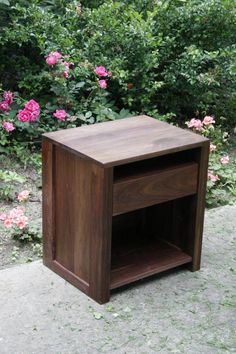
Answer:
54 147 91 282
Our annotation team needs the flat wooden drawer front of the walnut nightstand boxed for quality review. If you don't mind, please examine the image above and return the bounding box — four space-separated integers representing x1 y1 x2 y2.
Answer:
113 162 198 215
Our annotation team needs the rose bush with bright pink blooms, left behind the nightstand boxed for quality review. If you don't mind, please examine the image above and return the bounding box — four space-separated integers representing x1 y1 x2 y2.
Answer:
0 58 121 153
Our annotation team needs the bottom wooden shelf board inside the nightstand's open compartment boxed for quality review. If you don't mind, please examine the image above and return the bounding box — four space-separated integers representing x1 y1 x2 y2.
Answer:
110 240 192 289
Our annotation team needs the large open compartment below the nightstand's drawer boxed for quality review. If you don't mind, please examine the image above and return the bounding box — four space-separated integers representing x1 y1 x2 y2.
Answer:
110 196 194 289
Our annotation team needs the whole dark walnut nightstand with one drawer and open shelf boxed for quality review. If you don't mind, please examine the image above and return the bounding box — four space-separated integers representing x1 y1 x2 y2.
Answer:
43 116 209 304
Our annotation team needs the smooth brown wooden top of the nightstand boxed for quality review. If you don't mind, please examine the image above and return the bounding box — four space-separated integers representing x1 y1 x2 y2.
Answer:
43 115 208 167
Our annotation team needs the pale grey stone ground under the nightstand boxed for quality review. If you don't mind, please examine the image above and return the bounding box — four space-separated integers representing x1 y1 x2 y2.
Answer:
0 205 236 354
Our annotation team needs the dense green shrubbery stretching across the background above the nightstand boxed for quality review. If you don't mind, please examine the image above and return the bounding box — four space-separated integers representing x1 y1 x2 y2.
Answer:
0 0 236 133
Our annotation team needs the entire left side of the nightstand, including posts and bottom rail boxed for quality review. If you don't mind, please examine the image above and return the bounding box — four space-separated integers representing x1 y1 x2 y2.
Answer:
43 140 112 303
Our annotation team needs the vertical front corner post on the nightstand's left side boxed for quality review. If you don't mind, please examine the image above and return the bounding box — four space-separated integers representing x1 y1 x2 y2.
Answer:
88 164 113 304
